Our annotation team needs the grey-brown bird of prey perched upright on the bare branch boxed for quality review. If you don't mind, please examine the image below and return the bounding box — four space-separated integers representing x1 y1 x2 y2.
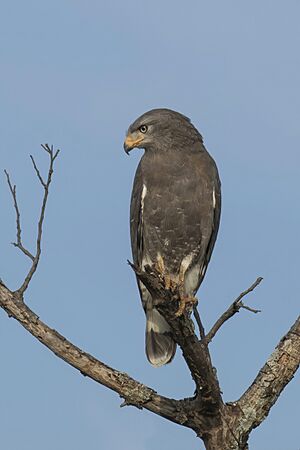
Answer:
124 109 221 367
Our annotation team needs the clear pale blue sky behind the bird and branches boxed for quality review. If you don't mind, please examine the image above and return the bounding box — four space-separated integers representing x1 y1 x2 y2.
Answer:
0 0 300 450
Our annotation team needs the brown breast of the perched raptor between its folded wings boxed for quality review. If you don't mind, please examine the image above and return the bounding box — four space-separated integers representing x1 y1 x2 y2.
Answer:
141 153 201 273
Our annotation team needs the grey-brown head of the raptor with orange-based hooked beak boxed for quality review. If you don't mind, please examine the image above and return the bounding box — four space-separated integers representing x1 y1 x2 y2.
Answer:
124 109 202 154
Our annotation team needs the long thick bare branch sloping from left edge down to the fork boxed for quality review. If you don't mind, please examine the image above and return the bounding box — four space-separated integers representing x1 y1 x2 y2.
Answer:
0 283 199 432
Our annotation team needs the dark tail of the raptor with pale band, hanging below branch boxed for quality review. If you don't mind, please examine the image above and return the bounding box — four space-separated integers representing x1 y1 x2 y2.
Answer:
146 306 176 367
